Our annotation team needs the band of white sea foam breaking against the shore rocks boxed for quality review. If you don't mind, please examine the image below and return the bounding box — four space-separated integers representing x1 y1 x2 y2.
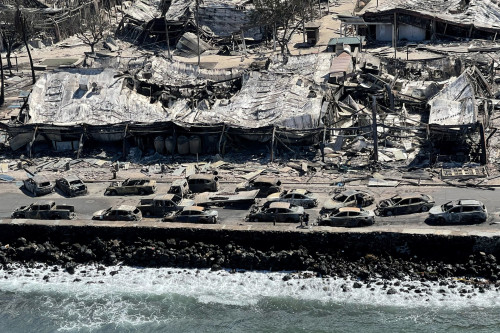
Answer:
0 266 500 315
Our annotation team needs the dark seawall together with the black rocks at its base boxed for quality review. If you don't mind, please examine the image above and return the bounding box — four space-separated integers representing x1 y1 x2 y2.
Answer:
0 221 500 282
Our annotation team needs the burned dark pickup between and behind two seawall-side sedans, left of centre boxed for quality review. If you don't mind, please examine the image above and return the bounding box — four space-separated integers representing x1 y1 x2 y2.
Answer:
137 194 194 217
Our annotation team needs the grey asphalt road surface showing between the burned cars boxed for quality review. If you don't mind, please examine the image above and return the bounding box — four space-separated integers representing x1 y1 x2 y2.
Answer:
0 181 500 228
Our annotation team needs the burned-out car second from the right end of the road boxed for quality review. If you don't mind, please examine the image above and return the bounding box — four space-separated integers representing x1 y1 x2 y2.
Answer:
375 193 435 216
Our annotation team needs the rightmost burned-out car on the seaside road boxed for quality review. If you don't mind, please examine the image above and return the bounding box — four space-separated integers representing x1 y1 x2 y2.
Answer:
429 200 488 224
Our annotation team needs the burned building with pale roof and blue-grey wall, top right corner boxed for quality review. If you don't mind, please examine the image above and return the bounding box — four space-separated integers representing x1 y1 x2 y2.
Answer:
360 0 500 42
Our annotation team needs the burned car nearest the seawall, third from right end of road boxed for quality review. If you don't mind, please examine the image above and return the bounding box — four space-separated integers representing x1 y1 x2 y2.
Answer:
318 207 375 227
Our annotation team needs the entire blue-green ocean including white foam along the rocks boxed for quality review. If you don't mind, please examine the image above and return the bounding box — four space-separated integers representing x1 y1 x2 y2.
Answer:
0 266 500 333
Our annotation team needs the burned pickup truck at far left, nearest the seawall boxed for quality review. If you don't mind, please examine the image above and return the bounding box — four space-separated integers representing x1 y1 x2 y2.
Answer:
11 201 76 220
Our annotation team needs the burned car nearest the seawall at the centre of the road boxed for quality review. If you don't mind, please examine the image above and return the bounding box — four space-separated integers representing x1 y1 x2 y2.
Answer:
247 202 309 223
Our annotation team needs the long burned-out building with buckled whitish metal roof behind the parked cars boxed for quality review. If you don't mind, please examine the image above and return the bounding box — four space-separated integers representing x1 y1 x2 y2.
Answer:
8 57 329 154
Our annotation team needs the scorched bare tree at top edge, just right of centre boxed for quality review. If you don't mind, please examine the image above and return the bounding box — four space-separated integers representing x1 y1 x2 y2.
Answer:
251 0 310 55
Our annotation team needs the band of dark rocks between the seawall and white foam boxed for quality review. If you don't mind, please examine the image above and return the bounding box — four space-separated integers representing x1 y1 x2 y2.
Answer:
0 237 500 294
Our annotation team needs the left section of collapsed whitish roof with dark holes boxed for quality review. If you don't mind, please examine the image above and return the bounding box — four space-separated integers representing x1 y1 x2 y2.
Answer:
28 69 167 125
